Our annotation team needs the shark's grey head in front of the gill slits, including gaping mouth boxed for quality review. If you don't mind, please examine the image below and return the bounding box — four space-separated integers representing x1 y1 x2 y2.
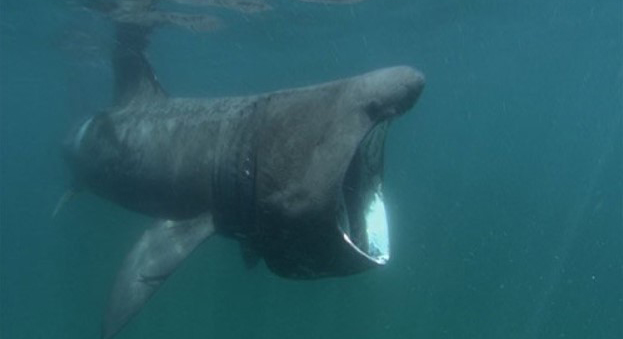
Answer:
256 67 424 279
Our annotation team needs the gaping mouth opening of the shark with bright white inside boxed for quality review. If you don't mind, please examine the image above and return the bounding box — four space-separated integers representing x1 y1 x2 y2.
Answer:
338 122 390 265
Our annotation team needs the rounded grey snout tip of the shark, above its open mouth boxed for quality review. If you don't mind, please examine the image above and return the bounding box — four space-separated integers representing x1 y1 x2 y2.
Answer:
358 66 425 120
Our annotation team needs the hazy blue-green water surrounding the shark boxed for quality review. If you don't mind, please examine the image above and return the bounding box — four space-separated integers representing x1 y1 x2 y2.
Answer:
0 0 623 339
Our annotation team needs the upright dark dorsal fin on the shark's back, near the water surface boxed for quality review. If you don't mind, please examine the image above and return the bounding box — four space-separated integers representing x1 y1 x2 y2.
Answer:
112 23 166 106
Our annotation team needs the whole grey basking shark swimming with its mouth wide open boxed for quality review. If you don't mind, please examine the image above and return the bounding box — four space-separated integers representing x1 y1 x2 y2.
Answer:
64 3 424 339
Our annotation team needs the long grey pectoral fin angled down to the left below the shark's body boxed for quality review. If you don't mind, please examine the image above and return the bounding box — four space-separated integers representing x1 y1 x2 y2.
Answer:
102 215 214 339
